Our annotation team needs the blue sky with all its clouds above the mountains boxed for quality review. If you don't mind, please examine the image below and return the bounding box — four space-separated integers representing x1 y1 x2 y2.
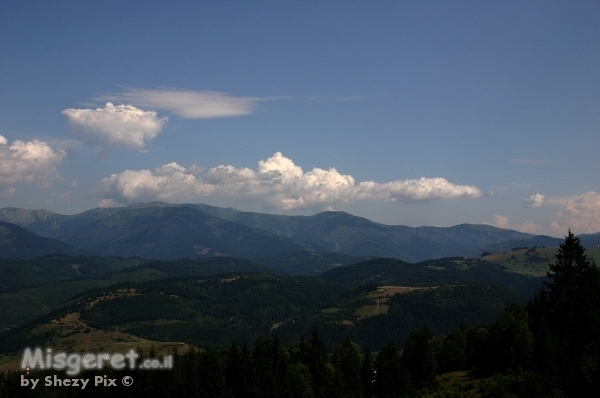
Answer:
0 0 600 237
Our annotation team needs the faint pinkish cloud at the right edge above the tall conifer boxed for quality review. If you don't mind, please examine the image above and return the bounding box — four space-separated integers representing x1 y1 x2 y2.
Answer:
550 191 600 235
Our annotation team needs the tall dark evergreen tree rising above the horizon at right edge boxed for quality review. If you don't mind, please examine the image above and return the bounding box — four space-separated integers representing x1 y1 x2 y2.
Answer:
527 230 600 396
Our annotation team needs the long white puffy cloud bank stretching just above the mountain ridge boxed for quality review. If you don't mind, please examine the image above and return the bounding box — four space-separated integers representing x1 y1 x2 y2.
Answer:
97 152 481 210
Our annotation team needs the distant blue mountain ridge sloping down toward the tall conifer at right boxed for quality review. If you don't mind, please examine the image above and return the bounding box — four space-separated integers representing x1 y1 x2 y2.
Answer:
189 205 544 262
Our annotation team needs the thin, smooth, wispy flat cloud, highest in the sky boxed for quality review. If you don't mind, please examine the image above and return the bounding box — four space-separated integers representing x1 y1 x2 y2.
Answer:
97 88 260 119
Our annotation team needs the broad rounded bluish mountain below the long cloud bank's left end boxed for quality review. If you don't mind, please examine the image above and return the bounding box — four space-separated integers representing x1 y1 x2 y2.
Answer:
65 206 312 260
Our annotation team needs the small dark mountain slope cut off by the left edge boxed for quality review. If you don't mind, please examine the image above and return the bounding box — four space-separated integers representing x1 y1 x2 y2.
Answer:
0 221 85 260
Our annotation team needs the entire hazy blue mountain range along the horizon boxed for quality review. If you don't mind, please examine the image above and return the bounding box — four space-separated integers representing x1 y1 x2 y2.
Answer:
0 202 600 265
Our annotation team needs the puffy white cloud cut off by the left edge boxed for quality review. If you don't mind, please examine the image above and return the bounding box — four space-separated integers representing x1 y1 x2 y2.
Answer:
0 135 67 193
